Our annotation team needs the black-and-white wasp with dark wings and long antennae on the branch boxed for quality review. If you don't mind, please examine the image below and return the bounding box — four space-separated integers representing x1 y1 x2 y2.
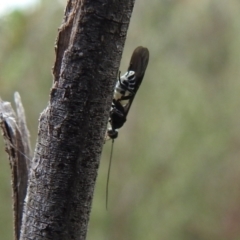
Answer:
106 46 149 208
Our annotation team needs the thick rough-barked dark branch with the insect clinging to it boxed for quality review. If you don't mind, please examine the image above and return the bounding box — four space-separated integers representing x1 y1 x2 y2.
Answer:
20 0 134 240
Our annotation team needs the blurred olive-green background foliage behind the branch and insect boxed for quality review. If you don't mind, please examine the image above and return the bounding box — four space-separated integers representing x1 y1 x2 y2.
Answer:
0 0 240 240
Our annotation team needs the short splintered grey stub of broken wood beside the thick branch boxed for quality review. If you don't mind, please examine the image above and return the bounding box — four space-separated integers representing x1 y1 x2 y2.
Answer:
0 93 30 240
